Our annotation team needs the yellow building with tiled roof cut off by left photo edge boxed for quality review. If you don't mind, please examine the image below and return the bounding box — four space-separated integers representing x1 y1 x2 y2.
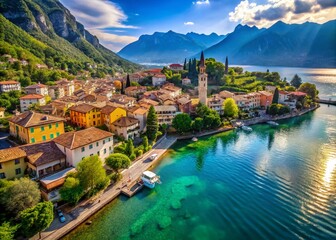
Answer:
0 147 27 179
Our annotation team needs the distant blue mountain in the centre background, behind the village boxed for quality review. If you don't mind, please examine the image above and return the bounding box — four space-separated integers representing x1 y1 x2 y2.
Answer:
118 31 225 63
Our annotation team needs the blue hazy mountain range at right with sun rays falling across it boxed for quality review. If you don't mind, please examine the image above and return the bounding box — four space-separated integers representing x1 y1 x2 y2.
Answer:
204 20 336 67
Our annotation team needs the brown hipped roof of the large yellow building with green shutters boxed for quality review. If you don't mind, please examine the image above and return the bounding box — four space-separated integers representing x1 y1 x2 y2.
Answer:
9 111 65 127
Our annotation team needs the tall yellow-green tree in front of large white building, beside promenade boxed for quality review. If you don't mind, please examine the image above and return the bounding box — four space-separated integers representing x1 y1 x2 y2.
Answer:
77 155 109 196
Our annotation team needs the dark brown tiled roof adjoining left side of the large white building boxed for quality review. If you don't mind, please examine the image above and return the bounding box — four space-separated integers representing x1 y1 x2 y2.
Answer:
19 141 65 166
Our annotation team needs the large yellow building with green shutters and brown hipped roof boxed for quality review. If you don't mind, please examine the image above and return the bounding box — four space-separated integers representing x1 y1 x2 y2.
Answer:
9 111 65 143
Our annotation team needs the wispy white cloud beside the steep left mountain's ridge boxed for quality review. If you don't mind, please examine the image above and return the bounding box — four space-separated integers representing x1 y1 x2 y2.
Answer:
61 0 136 29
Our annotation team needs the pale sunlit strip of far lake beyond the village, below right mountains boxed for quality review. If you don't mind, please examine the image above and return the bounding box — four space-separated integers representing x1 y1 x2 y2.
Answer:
236 66 336 100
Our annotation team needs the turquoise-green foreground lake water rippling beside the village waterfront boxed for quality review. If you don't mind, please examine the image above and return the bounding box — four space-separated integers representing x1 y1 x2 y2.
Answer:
66 105 336 240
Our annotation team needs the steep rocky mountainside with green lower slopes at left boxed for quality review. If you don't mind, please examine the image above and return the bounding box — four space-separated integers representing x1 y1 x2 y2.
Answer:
0 0 139 71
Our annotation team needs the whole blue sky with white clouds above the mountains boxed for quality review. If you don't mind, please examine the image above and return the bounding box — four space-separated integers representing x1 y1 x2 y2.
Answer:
61 0 336 51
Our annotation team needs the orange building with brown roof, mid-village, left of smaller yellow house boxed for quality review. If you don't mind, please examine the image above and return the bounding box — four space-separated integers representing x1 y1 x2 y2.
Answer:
69 103 103 128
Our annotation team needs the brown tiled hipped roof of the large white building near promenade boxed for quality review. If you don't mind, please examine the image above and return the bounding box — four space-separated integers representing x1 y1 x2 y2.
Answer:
53 127 113 149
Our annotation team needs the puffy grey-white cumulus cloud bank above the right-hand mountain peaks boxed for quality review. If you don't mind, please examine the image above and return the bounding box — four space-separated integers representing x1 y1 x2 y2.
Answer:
229 0 336 27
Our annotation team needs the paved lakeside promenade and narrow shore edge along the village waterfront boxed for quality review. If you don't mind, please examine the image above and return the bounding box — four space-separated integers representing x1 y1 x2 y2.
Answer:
39 105 320 240
